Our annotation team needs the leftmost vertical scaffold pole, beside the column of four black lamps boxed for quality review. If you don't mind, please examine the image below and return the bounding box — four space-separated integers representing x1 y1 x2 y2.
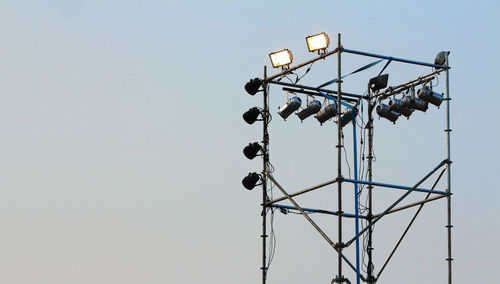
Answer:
261 66 269 284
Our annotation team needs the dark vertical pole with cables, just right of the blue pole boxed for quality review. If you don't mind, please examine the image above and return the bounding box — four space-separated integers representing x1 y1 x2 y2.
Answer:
366 86 375 284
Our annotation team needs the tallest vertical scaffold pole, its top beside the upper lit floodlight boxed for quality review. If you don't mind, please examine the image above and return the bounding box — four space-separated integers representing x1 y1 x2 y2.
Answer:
337 33 343 283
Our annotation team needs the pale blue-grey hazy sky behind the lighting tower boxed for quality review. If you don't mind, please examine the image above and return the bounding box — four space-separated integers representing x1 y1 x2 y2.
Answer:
0 0 500 284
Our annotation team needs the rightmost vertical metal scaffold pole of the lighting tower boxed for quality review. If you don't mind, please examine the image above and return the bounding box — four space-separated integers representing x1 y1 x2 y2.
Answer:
445 52 453 284
